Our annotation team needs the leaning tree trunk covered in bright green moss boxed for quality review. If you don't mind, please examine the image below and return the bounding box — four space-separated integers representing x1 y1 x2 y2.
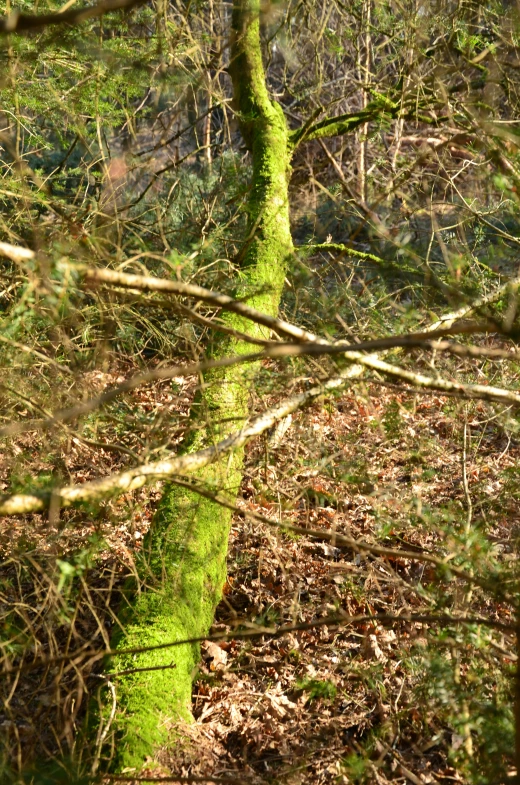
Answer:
108 0 293 769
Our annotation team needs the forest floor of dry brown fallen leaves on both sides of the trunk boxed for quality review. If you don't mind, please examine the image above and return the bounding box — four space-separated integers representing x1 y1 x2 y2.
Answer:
0 350 520 785
